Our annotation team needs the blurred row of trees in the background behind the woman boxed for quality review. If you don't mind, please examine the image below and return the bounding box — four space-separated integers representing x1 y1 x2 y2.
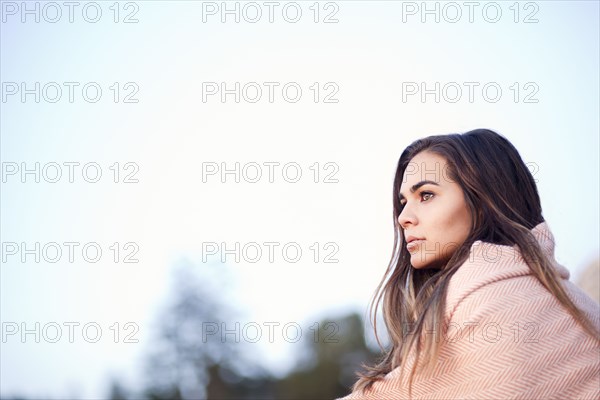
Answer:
118 265 384 400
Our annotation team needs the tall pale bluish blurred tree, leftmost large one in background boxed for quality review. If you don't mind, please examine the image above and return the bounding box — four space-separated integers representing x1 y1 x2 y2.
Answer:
144 264 243 399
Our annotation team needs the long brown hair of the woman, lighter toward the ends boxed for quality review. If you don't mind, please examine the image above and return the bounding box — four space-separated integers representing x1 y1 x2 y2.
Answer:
352 129 600 396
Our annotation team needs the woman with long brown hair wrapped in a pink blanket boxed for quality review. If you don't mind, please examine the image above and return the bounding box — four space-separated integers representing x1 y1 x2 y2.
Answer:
344 129 600 400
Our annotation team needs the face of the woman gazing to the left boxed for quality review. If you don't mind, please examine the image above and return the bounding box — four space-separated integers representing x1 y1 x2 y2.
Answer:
398 151 471 269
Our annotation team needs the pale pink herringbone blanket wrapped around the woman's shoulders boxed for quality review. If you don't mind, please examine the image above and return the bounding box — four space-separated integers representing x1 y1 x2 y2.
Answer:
343 222 600 400
